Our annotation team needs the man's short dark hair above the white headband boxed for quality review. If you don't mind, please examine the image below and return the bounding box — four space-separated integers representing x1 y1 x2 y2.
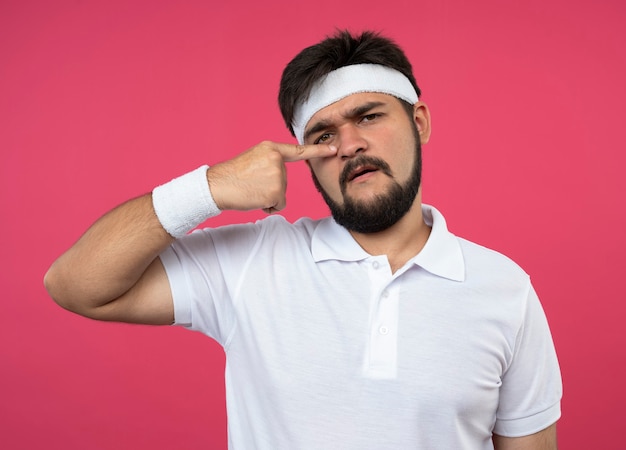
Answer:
278 30 421 134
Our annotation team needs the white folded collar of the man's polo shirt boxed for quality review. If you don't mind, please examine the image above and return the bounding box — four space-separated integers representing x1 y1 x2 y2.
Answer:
311 204 465 281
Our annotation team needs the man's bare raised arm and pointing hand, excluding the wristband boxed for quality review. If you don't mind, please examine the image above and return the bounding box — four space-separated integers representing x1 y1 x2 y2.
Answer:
44 142 336 325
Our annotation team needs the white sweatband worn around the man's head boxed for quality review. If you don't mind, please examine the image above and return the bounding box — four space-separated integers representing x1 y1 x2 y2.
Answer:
291 64 418 144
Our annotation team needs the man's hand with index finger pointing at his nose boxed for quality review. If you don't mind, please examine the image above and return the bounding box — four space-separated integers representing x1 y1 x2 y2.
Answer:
207 141 337 214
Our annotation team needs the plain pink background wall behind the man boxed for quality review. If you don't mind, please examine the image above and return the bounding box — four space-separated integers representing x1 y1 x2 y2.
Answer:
0 0 626 449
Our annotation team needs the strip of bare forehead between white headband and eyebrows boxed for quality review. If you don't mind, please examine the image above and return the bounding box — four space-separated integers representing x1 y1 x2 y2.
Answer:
306 92 401 128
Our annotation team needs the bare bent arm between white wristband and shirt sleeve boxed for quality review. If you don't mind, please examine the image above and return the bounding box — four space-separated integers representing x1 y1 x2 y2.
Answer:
44 194 174 324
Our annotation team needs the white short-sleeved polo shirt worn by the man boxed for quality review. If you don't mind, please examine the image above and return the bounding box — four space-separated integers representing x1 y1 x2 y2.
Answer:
161 206 561 450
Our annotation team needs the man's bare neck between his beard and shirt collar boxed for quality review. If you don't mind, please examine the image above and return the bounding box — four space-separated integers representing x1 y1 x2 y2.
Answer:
350 189 430 272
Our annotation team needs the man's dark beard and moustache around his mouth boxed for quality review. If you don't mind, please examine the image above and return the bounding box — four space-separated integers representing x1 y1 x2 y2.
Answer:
311 128 422 233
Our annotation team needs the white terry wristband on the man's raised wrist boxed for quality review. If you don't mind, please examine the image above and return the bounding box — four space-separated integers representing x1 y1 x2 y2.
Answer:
152 165 221 238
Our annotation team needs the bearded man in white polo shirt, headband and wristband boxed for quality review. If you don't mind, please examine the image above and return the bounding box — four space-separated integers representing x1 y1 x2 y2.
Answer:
45 32 561 450
